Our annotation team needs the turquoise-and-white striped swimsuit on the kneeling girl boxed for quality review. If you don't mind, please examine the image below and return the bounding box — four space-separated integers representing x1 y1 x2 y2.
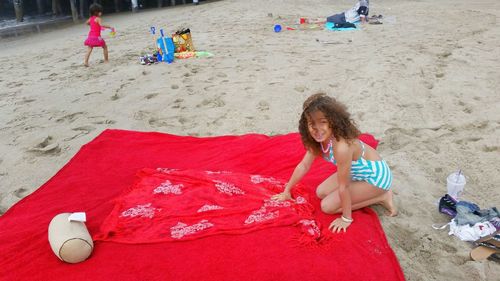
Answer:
321 140 392 190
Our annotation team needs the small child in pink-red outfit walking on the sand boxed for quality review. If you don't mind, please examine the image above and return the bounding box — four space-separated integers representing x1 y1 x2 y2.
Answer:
84 3 112 66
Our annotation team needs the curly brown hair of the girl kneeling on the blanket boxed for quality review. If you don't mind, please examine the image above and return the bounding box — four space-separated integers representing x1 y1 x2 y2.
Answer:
299 93 361 155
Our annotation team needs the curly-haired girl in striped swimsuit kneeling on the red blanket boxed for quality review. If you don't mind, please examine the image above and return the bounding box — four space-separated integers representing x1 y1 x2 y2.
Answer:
273 93 397 232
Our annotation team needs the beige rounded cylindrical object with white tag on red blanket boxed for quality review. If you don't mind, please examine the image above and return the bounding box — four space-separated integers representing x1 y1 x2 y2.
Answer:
49 213 94 263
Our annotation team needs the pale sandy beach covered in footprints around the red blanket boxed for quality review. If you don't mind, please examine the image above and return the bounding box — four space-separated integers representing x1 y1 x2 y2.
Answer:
0 0 500 281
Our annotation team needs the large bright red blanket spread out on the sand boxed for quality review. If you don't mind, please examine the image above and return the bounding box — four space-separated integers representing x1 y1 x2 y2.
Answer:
0 130 404 281
